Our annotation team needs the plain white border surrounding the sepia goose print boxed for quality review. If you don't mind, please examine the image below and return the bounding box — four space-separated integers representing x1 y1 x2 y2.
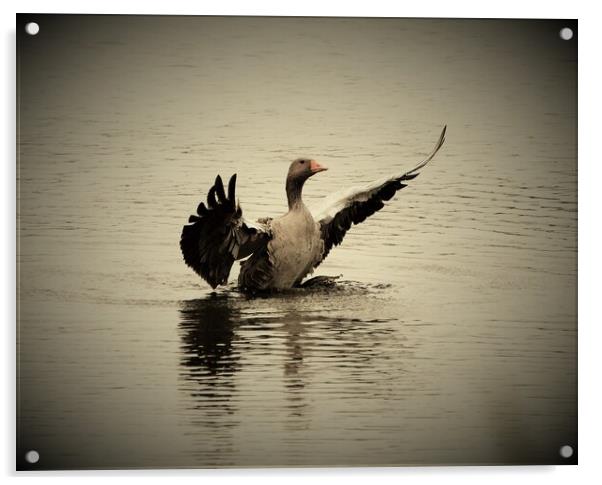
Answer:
0 0 602 485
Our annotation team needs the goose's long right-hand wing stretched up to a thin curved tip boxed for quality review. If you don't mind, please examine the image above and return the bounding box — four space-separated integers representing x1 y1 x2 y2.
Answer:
314 126 447 264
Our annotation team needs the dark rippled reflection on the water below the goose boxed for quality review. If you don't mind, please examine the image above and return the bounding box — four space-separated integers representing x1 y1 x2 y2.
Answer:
179 282 404 454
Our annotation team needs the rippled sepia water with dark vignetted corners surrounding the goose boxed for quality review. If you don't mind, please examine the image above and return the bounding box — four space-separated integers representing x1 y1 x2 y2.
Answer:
17 14 577 469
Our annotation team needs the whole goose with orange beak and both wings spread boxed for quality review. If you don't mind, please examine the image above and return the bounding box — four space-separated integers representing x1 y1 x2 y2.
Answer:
180 126 447 293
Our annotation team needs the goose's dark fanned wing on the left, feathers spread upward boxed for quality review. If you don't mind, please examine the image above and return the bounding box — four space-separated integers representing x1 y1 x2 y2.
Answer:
180 174 271 288
